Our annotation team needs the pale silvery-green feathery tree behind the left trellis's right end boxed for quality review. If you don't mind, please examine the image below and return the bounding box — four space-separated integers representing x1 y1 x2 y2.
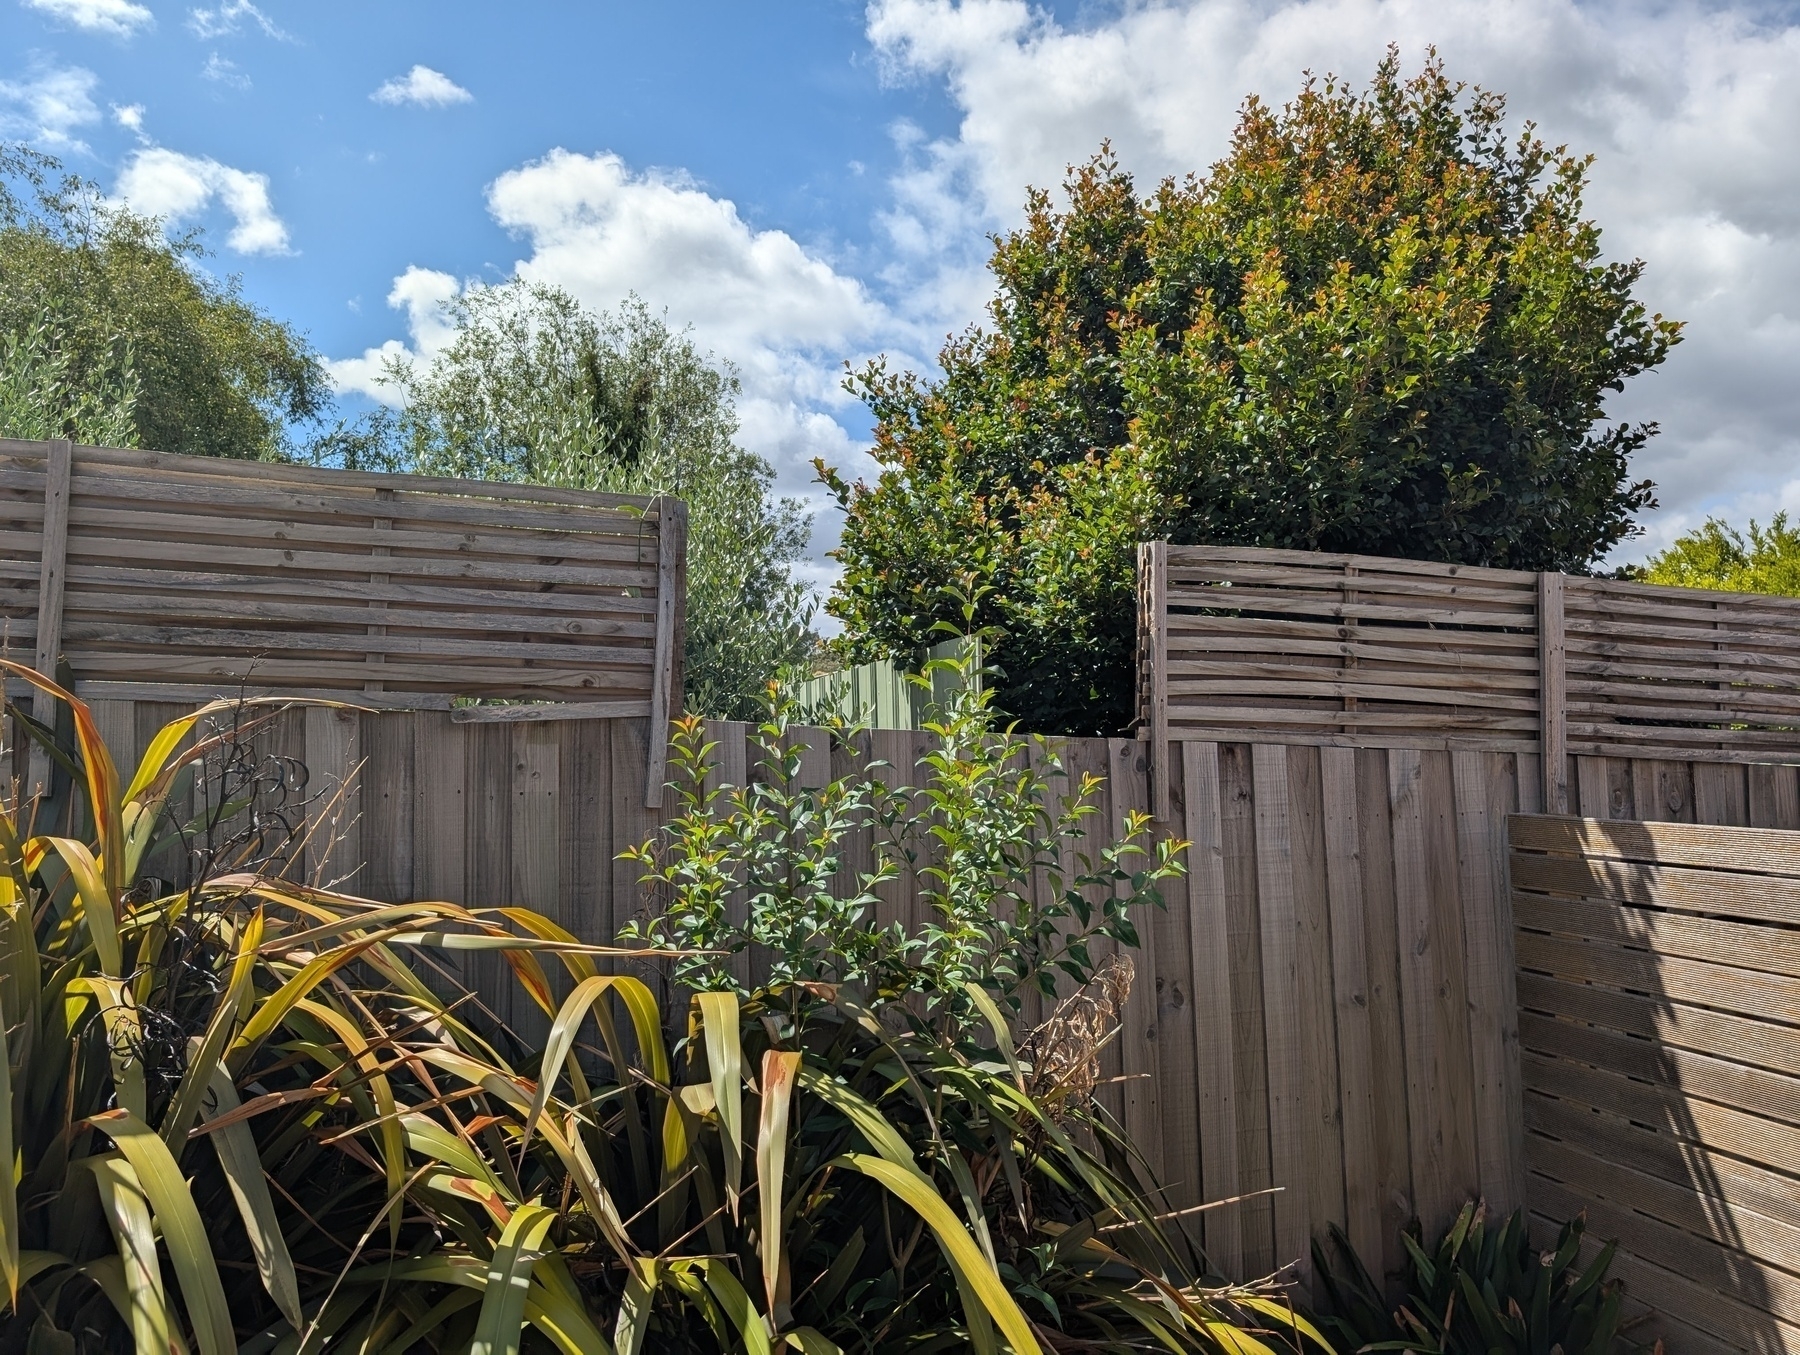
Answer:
331 281 814 720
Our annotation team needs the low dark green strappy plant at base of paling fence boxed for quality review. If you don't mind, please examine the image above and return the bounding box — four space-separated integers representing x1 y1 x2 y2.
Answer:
1312 1202 1627 1355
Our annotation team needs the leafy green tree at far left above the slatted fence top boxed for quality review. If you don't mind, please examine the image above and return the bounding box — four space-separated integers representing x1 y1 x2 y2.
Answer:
0 148 331 461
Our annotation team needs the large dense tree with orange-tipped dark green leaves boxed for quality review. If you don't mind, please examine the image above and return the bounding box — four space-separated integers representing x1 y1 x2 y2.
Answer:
821 52 1679 732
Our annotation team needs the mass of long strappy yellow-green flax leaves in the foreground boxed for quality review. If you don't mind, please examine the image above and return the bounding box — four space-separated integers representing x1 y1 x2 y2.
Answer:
0 666 1323 1355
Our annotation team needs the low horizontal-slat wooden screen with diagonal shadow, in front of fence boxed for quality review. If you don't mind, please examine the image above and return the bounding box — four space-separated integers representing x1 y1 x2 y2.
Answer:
1510 813 1800 1351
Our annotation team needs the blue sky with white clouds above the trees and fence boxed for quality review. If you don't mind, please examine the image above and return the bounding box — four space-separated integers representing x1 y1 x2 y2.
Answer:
0 0 1800 579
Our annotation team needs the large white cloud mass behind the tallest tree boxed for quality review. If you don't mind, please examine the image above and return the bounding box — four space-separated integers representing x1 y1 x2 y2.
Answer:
868 0 1800 554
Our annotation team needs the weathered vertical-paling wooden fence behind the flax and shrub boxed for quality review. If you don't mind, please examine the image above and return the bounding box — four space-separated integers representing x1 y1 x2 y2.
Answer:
95 700 1537 1276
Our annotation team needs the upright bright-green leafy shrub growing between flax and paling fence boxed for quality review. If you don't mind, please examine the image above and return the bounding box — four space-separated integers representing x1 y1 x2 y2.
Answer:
626 629 1186 1024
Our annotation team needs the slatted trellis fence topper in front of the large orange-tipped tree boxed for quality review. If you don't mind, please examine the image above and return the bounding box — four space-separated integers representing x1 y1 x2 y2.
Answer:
1139 542 1800 810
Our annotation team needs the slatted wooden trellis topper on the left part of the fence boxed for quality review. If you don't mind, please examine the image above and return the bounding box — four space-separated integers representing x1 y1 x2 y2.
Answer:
0 441 686 802
